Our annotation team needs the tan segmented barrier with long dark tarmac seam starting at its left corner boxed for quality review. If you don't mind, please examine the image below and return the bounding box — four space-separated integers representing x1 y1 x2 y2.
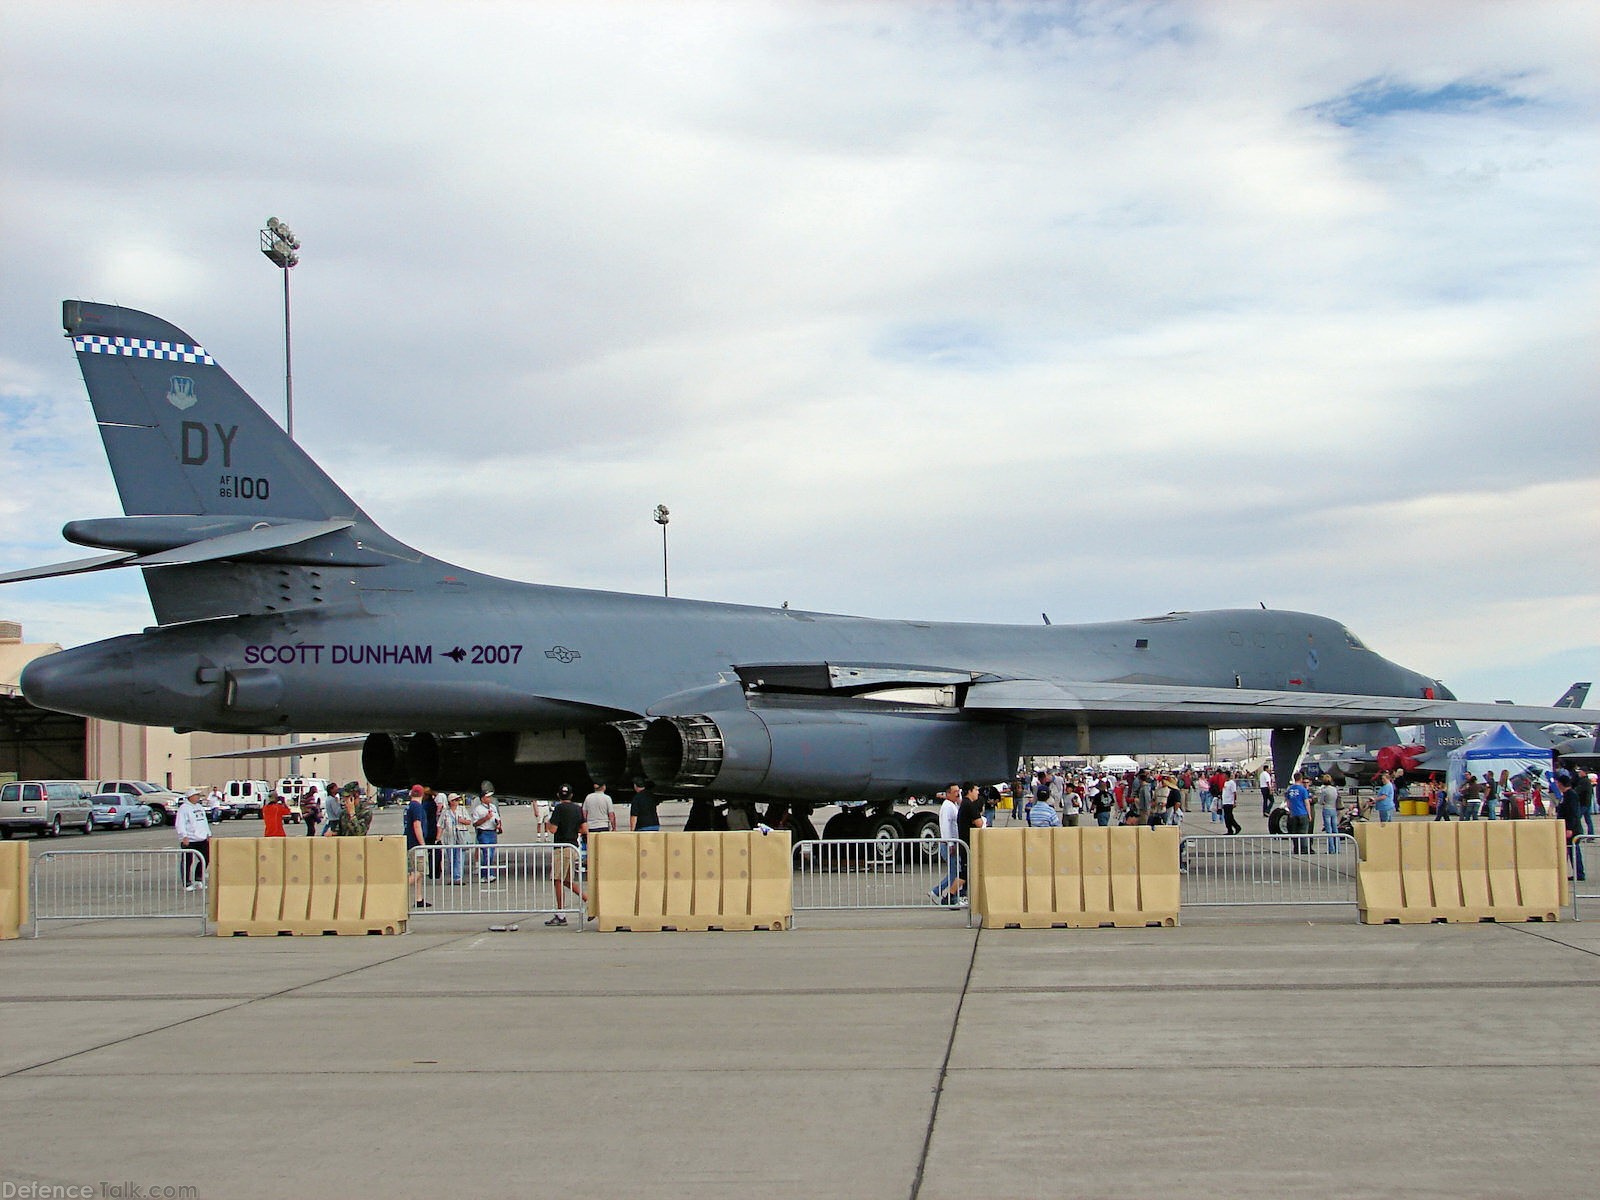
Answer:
971 826 1179 930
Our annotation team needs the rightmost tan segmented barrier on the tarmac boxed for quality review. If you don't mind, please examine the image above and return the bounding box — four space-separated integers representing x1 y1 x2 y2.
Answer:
1355 821 1568 925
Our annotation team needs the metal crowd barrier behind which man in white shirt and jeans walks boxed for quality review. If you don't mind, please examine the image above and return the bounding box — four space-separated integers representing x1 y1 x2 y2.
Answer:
794 838 973 925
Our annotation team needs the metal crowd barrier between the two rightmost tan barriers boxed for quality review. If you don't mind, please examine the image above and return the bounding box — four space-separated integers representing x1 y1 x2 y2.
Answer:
1178 834 1358 909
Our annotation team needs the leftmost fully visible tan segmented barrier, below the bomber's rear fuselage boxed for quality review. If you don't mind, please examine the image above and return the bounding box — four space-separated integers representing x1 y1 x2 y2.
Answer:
210 837 410 938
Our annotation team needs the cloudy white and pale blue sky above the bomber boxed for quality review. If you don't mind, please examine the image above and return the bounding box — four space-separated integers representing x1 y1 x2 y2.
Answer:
0 0 1600 702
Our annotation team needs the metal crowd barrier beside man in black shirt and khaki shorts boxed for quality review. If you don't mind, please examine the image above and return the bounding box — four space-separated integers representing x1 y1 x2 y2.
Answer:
411 842 587 928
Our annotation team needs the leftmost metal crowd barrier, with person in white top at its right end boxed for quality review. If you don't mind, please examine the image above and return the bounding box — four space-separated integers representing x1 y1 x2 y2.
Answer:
30 846 206 938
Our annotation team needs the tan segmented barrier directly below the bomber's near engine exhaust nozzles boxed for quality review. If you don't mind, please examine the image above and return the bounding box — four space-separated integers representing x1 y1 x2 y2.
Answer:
589 830 794 933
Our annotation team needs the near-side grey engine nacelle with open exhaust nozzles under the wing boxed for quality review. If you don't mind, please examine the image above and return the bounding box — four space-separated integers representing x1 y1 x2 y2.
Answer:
638 707 1014 803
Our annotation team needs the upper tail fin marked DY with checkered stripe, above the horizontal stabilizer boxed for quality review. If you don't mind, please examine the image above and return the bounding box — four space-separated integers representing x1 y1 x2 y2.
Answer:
61 301 366 523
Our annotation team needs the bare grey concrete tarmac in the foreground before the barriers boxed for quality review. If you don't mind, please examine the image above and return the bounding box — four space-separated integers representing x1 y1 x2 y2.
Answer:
0 910 1600 1200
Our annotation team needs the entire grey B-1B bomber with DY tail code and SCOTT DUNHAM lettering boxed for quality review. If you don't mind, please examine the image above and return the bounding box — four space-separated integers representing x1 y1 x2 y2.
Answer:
0 301 1600 837
